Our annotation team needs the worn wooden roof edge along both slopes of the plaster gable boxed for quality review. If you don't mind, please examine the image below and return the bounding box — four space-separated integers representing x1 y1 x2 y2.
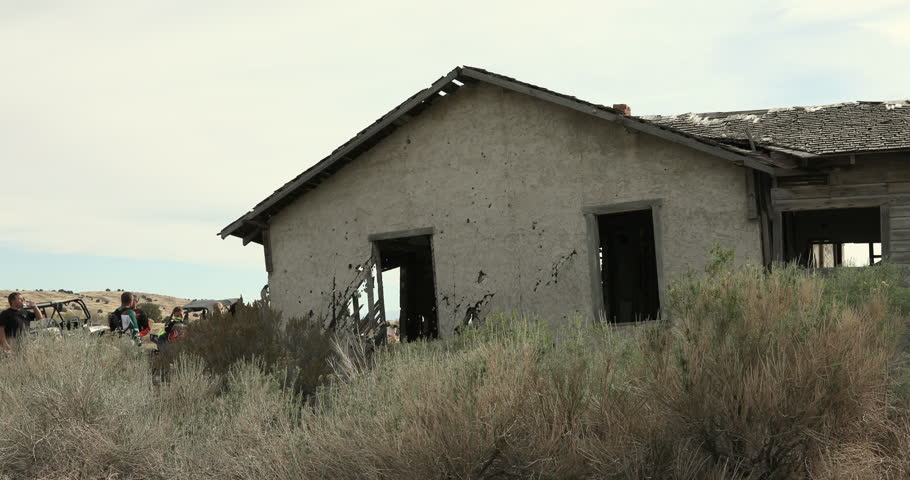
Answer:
218 66 774 240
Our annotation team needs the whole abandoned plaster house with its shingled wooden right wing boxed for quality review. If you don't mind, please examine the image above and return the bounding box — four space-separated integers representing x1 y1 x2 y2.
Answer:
220 67 910 340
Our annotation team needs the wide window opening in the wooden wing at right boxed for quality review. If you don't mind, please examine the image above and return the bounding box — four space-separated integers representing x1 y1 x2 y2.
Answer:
783 207 882 268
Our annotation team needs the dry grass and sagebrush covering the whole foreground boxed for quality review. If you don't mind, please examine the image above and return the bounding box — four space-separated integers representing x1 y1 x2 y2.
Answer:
0 260 910 479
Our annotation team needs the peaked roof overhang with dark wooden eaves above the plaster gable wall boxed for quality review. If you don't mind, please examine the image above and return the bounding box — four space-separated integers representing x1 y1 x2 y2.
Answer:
219 67 776 245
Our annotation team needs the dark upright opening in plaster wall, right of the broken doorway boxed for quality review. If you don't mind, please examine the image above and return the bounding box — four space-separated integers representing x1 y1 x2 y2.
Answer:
596 209 660 323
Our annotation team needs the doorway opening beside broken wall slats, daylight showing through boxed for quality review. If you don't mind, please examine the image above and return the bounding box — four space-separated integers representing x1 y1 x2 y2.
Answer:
374 235 439 342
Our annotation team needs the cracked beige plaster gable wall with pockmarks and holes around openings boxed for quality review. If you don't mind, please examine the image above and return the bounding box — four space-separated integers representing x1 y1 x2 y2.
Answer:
269 84 761 335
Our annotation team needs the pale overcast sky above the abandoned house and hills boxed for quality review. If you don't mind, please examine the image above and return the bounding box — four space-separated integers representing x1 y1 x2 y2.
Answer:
0 0 910 298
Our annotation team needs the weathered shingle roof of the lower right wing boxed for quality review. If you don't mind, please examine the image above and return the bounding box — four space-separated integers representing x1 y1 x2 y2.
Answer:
644 100 910 158
